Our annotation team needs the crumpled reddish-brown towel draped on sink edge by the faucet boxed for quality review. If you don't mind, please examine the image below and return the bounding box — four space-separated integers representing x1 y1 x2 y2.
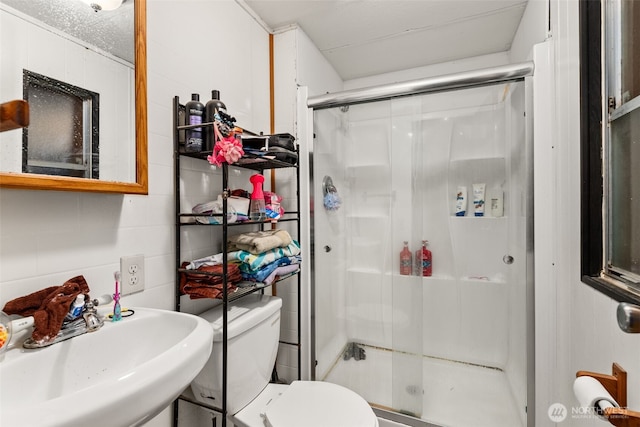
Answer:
2 276 89 342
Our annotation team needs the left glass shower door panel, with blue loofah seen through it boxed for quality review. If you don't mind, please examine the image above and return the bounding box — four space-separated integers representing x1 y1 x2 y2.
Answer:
314 100 423 417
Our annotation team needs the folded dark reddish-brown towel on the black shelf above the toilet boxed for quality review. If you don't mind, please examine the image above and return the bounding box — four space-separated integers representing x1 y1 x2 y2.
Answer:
180 262 242 299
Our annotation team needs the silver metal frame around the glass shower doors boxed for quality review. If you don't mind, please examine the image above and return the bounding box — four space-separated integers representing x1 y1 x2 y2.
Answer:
298 61 535 427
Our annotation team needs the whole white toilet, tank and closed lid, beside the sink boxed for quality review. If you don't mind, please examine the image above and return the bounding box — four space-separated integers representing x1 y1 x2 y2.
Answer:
191 294 378 427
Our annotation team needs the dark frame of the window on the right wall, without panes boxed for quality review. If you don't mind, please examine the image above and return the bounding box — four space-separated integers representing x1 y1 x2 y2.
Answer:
580 0 640 304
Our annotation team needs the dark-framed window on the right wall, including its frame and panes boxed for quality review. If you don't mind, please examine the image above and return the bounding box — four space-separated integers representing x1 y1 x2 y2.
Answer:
580 0 640 303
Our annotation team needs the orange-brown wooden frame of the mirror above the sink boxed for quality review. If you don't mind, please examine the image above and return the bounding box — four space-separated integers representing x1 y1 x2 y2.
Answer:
0 0 148 194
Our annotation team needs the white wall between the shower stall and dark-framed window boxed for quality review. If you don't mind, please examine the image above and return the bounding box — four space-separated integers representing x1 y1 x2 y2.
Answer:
535 0 640 427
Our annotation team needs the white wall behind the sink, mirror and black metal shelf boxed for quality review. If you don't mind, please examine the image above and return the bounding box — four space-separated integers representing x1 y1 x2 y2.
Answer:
0 0 269 426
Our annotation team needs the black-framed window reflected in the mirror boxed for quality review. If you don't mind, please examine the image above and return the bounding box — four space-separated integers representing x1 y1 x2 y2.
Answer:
22 70 100 179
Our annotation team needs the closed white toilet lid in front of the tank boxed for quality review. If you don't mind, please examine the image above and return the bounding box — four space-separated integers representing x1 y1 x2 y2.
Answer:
264 381 378 427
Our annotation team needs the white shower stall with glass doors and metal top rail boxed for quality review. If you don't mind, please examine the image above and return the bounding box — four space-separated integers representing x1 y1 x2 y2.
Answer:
307 63 533 427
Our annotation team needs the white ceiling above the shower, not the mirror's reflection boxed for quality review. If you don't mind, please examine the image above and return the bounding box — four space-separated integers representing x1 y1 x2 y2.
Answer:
244 0 527 80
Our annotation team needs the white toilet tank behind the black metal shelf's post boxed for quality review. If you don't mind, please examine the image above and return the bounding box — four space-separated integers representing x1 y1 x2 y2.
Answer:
191 294 282 415
